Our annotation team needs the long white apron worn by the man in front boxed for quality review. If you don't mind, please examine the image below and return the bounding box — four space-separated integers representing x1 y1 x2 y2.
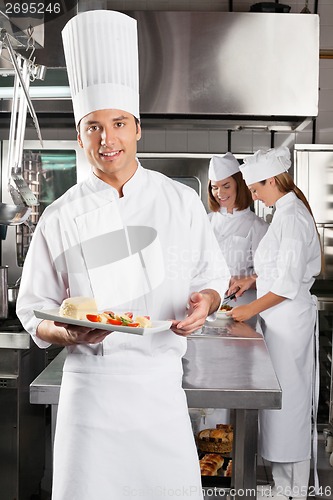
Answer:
52 352 203 500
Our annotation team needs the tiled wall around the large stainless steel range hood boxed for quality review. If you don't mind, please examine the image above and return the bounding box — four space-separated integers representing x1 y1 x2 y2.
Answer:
79 0 333 153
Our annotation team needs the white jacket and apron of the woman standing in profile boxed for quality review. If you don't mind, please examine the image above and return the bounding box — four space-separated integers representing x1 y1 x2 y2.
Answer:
254 192 321 462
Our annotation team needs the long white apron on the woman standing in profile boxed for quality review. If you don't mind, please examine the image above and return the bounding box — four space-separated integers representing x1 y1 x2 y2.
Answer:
259 290 317 462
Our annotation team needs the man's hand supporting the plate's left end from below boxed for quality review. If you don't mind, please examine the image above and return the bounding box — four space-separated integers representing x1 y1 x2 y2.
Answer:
36 320 112 346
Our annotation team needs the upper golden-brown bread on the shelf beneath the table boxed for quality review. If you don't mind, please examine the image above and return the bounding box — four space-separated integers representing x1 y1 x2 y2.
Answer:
197 424 233 453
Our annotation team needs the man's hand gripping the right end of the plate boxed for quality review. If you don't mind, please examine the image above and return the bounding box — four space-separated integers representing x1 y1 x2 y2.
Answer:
171 292 211 337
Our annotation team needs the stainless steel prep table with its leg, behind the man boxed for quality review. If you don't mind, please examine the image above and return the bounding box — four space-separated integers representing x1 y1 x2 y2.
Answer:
30 321 281 499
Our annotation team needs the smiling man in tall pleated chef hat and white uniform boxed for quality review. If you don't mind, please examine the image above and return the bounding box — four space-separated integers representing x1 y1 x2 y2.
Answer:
17 10 230 500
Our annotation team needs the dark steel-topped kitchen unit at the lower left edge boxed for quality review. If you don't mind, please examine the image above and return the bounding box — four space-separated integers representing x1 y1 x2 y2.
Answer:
0 330 46 500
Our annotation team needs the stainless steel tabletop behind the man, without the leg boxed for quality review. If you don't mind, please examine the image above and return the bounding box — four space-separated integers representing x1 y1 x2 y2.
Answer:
30 321 281 409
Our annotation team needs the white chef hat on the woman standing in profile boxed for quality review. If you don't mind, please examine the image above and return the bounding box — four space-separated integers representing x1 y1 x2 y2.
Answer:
240 146 291 186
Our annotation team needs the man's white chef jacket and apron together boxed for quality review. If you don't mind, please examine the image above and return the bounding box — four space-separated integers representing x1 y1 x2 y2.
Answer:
17 164 230 500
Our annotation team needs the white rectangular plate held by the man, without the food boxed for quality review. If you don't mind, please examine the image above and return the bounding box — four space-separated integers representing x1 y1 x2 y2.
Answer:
34 309 171 335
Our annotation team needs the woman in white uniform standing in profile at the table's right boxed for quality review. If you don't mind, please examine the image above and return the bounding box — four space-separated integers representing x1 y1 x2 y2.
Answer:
229 147 321 499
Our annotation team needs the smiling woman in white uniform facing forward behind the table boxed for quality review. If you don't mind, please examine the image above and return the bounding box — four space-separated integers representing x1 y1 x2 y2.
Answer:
208 152 268 306
